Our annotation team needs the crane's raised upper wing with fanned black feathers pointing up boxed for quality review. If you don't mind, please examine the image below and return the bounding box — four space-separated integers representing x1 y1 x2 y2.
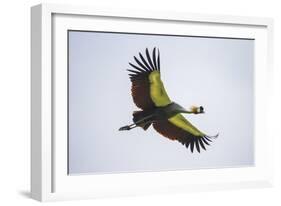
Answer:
128 48 172 110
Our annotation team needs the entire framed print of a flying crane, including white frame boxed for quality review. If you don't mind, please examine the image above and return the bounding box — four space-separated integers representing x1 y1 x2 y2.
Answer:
31 4 273 201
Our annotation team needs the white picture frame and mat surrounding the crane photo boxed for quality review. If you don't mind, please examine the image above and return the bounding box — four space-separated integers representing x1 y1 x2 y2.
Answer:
31 4 273 201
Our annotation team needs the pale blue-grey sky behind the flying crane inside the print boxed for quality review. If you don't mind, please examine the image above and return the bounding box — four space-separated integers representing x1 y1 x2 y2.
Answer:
69 31 254 174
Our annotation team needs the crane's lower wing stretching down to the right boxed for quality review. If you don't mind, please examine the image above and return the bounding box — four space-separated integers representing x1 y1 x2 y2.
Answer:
153 114 218 152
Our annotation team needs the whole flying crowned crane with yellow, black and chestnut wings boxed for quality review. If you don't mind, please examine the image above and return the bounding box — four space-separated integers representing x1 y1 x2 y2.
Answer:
119 48 216 152
